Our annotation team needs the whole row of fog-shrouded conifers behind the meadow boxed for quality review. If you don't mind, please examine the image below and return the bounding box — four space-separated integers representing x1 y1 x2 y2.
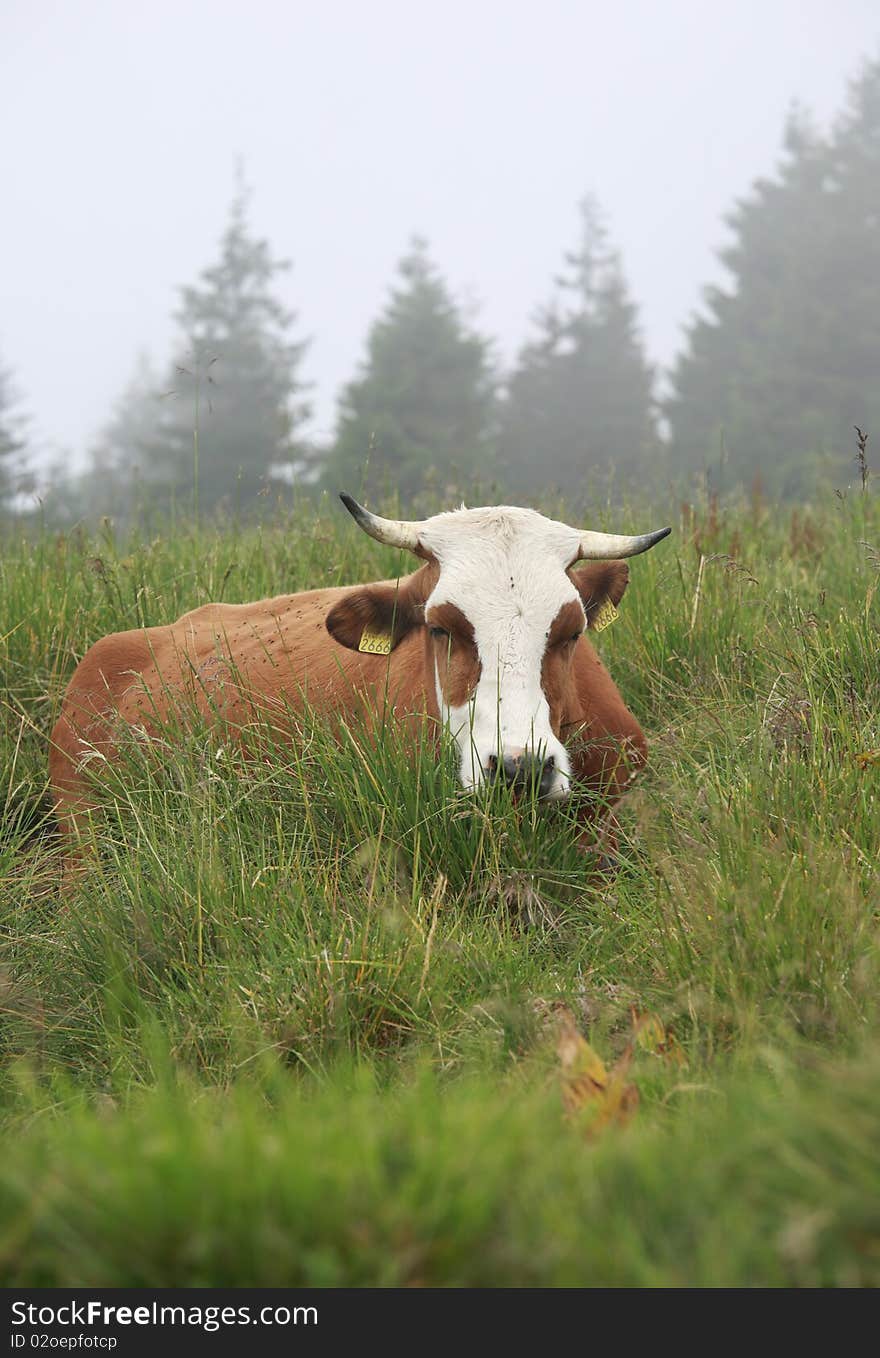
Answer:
0 60 880 521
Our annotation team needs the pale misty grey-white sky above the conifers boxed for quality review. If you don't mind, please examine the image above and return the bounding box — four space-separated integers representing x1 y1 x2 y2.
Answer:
0 0 880 478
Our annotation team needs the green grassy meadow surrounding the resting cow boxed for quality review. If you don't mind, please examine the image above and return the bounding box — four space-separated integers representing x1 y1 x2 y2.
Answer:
0 489 880 1286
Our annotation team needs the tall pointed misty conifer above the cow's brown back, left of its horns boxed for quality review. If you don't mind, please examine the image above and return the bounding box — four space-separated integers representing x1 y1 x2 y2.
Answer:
152 187 308 509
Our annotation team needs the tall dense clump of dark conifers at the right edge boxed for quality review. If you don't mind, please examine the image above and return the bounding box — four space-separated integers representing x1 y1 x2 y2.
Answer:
665 61 880 496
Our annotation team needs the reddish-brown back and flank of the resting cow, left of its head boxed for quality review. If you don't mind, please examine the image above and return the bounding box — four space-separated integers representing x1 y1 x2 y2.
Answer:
49 587 429 847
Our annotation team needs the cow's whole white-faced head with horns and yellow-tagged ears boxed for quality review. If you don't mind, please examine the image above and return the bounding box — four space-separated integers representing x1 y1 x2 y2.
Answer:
327 494 671 797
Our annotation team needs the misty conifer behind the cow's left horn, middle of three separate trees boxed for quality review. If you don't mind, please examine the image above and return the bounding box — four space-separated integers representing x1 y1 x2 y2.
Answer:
325 238 494 500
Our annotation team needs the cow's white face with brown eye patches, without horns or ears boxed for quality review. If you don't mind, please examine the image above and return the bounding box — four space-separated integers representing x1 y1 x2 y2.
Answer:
420 507 585 797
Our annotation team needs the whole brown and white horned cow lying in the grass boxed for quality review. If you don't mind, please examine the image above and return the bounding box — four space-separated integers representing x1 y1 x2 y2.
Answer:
50 494 671 849
